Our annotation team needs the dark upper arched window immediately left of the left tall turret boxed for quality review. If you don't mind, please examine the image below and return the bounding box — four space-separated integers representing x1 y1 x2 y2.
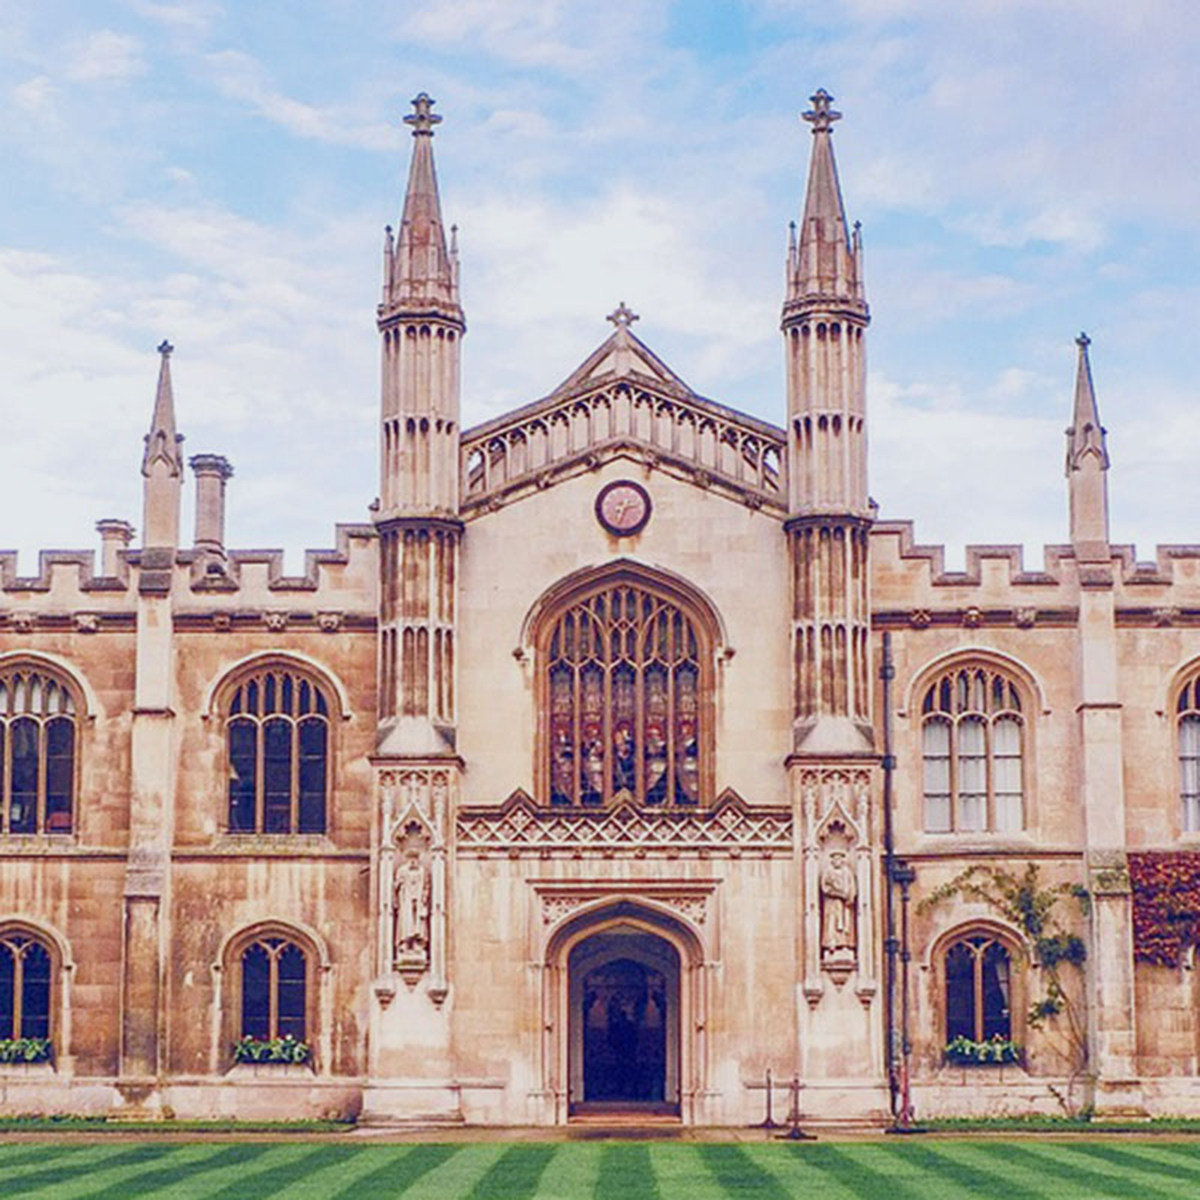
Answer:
226 665 329 833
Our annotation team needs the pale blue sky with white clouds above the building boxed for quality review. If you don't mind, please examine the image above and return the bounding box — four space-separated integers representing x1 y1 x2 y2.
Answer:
0 0 1200 571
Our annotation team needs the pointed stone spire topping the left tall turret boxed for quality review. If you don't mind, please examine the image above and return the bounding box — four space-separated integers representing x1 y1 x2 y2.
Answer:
380 91 462 322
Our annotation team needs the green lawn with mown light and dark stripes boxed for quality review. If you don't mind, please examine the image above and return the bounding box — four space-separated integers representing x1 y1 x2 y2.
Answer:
0 1138 1200 1200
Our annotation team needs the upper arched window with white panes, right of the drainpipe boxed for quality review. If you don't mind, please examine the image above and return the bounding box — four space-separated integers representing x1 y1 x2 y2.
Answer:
920 664 1026 833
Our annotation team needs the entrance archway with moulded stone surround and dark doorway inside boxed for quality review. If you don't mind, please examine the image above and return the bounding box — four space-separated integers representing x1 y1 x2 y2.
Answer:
542 899 708 1123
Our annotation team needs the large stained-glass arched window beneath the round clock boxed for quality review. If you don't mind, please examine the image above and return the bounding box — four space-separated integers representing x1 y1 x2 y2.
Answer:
539 577 712 805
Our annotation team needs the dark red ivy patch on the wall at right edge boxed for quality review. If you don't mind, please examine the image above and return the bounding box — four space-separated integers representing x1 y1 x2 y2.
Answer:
1129 851 1200 967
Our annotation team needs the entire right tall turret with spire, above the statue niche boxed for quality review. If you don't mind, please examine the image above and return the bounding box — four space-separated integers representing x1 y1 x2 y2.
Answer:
781 89 874 758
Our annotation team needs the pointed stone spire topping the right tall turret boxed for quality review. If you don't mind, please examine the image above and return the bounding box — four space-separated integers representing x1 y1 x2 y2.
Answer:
787 88 866 313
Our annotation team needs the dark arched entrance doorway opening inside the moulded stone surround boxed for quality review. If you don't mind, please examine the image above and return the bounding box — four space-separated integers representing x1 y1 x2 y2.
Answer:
568 924 680 1115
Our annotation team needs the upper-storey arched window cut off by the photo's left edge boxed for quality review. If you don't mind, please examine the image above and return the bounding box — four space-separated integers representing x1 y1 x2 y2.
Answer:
0 664 77 833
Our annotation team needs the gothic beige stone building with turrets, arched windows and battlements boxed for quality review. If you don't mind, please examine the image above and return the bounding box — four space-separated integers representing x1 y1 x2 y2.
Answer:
0 92 1200 1126
